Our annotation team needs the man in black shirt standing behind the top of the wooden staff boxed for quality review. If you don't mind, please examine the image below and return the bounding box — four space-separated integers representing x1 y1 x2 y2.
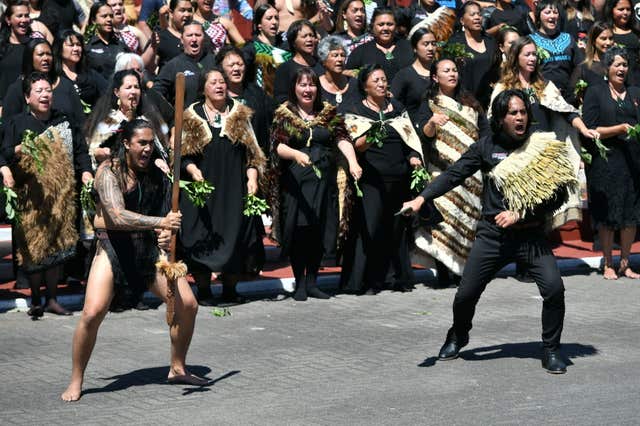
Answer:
153 21 215 107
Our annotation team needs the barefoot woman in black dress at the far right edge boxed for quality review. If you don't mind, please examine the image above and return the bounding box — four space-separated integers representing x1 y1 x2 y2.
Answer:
582 47 640 280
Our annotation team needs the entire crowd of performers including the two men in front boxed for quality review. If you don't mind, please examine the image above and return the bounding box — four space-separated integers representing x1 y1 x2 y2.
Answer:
0 0 640 400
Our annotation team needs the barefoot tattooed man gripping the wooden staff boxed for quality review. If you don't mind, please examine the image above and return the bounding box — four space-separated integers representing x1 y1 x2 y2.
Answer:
62 119 208 401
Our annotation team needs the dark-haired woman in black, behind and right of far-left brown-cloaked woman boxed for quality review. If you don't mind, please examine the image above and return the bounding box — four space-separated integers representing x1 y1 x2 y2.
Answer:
53 30 109 114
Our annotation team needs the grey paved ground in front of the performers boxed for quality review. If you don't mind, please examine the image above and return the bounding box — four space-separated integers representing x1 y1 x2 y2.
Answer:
0 274 640 425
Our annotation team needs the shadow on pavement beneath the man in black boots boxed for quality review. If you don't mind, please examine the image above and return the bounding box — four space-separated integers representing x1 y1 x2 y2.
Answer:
418 342 598 367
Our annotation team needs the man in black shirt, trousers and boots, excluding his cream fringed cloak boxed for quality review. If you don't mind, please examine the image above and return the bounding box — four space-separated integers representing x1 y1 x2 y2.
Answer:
403 90 566 374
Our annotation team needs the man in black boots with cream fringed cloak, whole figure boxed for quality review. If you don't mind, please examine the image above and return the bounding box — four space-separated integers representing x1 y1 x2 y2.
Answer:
403 90 577 374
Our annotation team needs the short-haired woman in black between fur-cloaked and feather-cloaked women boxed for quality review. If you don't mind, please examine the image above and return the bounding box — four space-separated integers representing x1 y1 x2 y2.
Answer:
216 46 275 152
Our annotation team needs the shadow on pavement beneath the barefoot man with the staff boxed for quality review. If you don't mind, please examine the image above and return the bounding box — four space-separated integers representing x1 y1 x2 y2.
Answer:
82 365 240 395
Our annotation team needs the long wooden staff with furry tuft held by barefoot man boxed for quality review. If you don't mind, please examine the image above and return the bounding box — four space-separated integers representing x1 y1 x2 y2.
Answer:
156 72 187 326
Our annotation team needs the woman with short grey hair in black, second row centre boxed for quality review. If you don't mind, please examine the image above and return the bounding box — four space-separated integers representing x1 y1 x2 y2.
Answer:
318 36 358 106
